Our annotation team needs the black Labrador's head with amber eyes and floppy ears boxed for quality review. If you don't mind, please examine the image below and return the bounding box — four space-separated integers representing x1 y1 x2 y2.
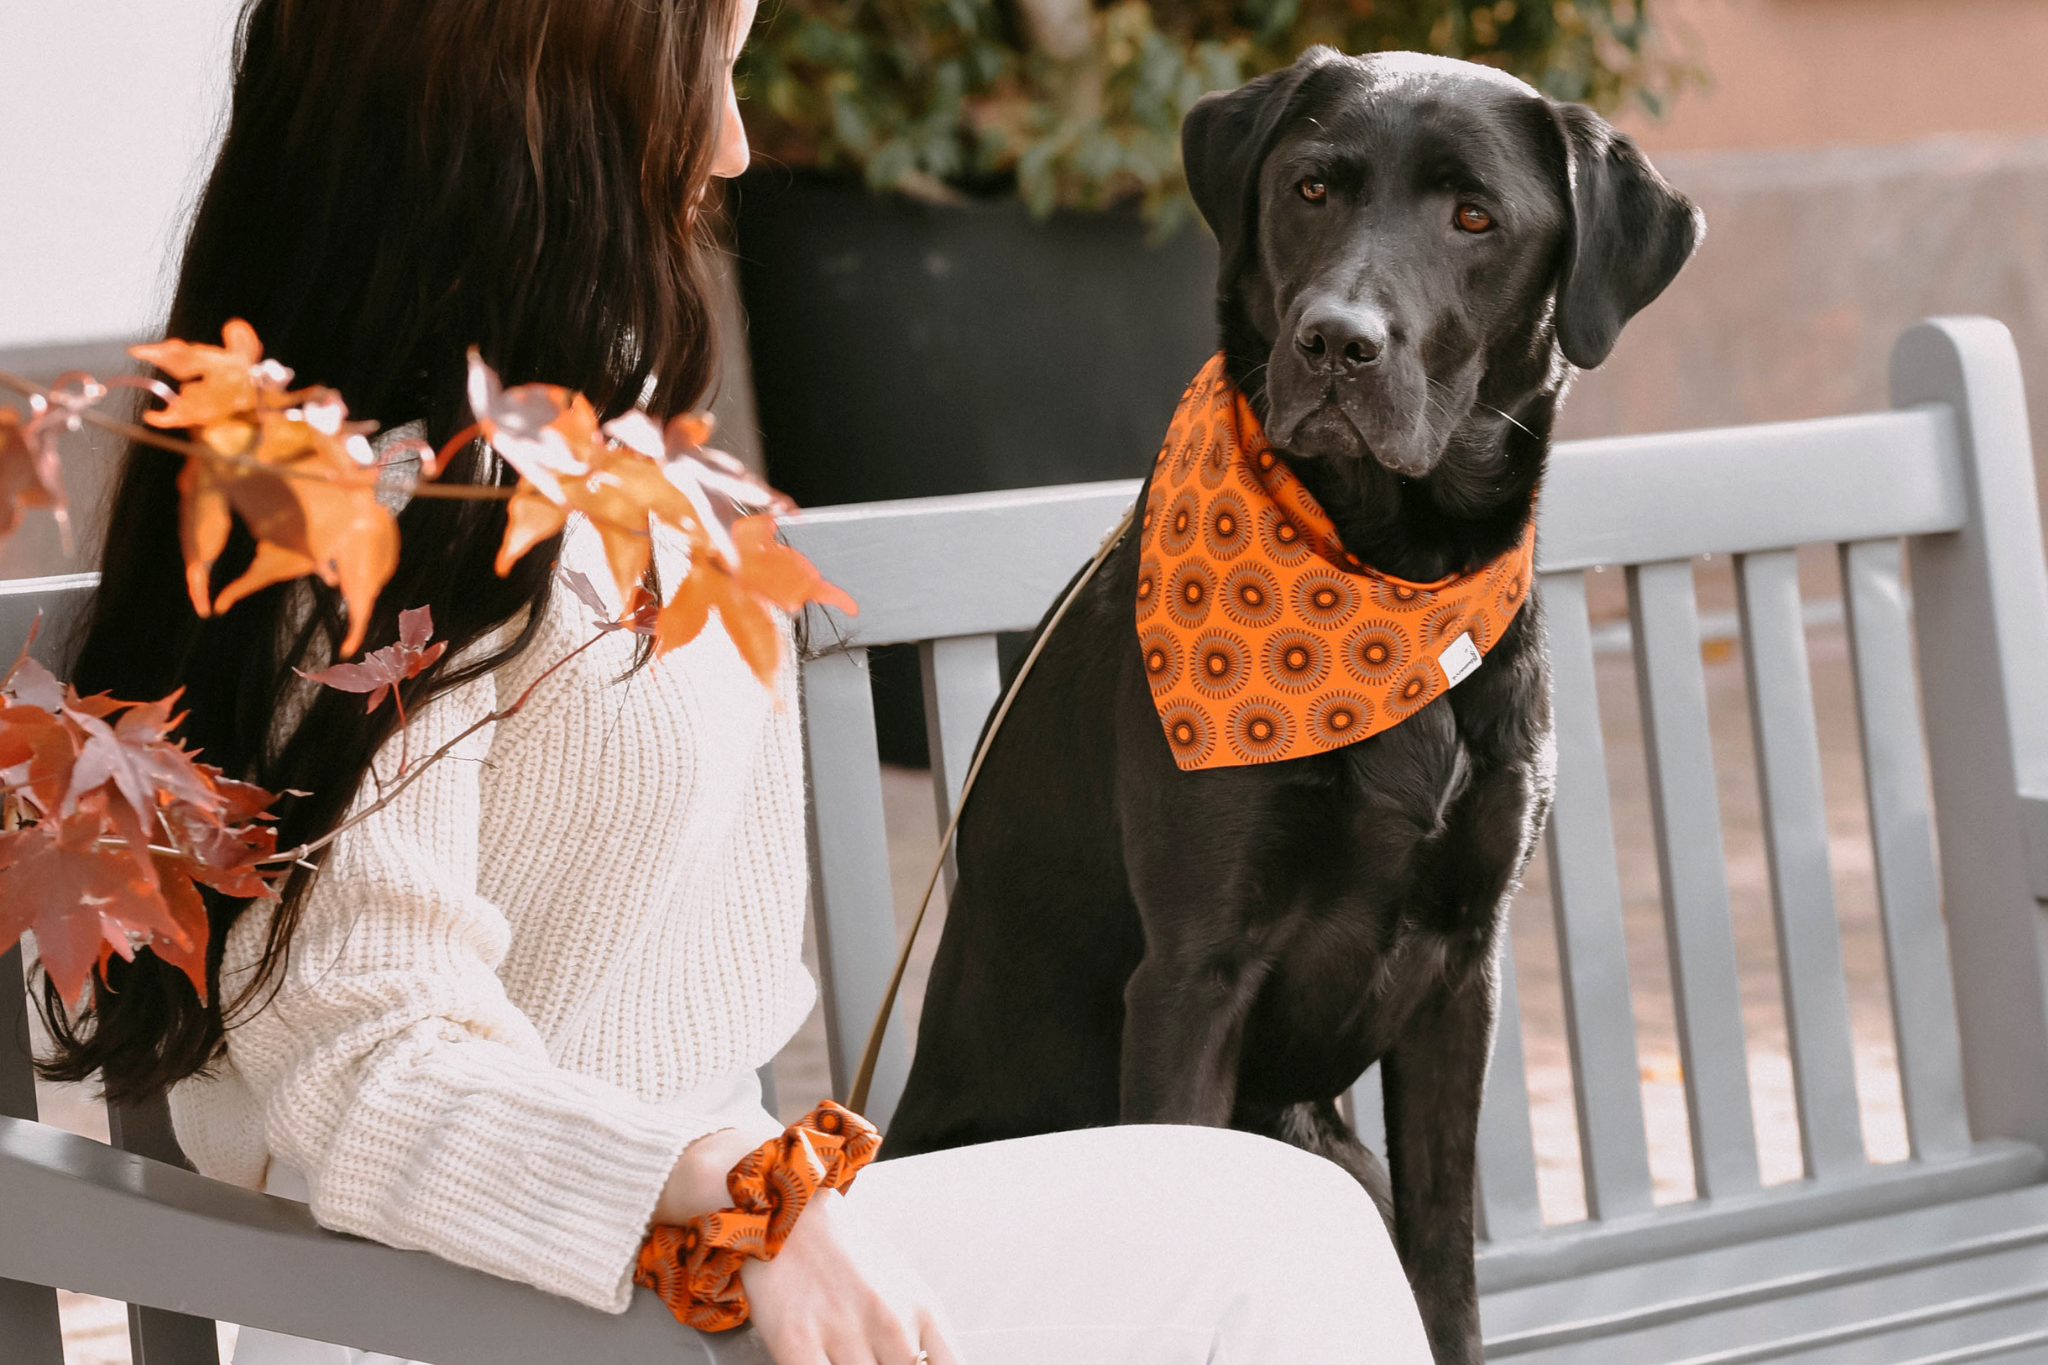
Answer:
1182 47 1704 479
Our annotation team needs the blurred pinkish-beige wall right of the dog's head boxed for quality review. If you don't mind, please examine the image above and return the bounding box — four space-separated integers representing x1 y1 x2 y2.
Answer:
1565 0 2048 444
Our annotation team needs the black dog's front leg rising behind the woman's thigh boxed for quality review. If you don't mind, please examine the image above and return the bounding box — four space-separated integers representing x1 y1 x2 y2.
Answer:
1120 950 1266 1128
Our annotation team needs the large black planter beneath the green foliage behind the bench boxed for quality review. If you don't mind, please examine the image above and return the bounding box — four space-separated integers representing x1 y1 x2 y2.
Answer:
733 170 1217 763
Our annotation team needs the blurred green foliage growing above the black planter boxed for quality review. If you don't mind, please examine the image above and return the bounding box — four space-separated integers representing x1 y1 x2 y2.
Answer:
739 0 1690 222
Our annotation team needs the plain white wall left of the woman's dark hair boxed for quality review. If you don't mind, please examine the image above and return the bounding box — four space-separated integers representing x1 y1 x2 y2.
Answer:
0 0 242 348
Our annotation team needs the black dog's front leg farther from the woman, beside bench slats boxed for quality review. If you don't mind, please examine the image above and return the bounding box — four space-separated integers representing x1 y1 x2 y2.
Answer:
1382 970 1493 1365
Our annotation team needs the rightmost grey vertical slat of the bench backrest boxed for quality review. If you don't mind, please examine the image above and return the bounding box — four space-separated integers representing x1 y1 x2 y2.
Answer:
1841 540 1970 1160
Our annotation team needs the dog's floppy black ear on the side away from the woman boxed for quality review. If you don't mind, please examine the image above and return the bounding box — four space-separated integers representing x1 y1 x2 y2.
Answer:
1552 104 1706 370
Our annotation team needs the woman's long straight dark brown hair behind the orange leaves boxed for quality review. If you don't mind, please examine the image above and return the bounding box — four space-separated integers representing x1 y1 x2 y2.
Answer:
41 0 737 1101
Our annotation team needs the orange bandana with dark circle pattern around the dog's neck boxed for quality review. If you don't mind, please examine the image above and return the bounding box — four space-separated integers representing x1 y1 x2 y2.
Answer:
1137 354 1536 772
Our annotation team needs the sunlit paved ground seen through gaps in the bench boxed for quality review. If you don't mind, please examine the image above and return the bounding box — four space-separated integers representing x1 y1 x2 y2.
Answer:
45 555 1933 1365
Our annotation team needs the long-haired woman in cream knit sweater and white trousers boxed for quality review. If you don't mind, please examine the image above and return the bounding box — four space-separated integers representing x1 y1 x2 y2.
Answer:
39 0 1427 1365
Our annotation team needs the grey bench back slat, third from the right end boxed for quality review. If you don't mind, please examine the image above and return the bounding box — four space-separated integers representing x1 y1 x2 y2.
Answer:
1628 559 1759 1199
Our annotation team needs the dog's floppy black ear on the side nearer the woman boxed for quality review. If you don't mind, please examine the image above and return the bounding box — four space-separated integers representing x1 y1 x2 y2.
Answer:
1180 47 1337 289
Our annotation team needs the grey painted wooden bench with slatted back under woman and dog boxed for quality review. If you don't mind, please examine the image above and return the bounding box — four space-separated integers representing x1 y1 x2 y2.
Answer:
0 319 2048 1365
